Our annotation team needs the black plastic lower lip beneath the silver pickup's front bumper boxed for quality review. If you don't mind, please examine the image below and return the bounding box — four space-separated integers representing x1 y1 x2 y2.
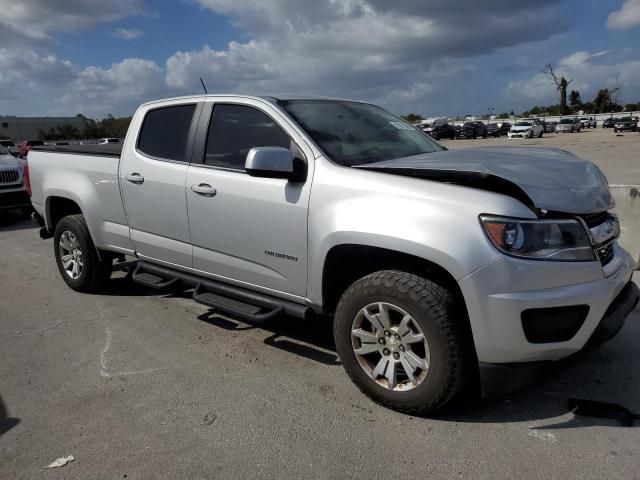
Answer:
479 282 640 398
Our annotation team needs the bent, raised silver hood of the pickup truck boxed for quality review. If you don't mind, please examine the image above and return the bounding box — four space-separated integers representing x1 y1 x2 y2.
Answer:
355 147 614 214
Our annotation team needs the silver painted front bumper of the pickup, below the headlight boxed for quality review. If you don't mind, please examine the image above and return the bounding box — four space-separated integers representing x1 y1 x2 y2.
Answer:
459 242 635 363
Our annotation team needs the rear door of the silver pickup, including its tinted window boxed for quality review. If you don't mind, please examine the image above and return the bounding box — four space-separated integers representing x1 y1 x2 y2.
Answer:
119 99 202 267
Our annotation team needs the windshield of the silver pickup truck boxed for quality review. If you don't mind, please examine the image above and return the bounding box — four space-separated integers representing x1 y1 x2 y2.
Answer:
278 100 445 166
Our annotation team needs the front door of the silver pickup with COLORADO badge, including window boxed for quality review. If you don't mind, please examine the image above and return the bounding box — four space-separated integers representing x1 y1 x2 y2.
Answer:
186 98 313 297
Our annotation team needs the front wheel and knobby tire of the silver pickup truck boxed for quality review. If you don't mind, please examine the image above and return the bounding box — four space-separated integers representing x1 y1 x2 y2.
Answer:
333 270 473 414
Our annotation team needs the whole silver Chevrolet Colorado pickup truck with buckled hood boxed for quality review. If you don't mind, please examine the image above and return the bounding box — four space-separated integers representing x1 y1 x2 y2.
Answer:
28 95 638 412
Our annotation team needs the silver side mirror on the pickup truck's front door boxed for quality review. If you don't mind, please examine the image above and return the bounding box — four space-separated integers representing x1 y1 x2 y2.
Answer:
244 147 306 181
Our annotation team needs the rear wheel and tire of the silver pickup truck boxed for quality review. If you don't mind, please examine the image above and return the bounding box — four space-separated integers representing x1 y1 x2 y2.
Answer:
53 215 113 293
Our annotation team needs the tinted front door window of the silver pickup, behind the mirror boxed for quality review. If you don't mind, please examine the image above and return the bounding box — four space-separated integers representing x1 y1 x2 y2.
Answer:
204 105 291 170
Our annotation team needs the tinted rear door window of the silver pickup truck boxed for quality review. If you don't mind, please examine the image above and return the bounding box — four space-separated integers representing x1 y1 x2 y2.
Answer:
138 104 196 162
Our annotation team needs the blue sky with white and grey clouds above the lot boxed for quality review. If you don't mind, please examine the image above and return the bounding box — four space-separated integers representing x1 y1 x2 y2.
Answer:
0 0 640 118
